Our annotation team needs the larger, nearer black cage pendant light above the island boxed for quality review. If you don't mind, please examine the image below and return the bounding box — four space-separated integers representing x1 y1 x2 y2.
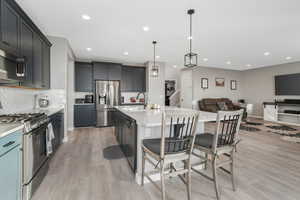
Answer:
184 9 198 67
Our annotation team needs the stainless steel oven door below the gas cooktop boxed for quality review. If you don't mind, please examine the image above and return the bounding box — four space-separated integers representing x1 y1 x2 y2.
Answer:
23 123 48 184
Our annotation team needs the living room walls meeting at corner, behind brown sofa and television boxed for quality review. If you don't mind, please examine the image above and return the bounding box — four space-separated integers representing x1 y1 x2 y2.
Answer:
178 62 300 117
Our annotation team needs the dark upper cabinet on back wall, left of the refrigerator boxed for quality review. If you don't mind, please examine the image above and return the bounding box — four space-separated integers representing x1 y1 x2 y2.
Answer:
75 62 93 92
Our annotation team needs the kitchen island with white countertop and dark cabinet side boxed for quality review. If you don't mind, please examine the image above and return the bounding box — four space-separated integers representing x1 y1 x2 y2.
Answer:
115 106 217 184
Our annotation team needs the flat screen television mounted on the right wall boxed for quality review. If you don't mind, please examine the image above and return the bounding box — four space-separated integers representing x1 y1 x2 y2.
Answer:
275 73 300 95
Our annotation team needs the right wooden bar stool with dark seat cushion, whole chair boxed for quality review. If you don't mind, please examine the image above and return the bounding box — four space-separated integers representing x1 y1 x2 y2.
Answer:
192 110 243 200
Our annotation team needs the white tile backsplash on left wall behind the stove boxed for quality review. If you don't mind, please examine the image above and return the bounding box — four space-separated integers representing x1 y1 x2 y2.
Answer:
0 87 66 114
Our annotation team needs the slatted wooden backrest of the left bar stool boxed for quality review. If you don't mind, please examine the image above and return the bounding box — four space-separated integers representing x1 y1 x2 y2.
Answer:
160 110 199 158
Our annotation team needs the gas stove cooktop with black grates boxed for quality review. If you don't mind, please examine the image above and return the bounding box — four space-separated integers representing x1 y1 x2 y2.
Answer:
0 113 49 133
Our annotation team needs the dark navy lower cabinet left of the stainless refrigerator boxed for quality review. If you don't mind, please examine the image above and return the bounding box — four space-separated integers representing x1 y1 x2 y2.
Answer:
74 104 96 127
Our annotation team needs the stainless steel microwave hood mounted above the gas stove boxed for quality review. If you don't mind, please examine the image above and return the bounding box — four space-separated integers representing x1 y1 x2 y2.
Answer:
0 49 25 85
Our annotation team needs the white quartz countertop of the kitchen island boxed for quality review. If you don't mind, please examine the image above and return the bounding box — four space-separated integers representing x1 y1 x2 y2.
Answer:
115 106 217 127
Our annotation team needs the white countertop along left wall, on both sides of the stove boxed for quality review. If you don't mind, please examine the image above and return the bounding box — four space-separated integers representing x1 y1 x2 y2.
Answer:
0 105 65 138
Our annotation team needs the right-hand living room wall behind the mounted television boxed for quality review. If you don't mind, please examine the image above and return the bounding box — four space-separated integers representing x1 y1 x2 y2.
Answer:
242 62 300 116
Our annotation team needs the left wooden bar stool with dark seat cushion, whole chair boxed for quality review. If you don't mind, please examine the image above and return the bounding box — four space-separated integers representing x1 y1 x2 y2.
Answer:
142 110 199 200
